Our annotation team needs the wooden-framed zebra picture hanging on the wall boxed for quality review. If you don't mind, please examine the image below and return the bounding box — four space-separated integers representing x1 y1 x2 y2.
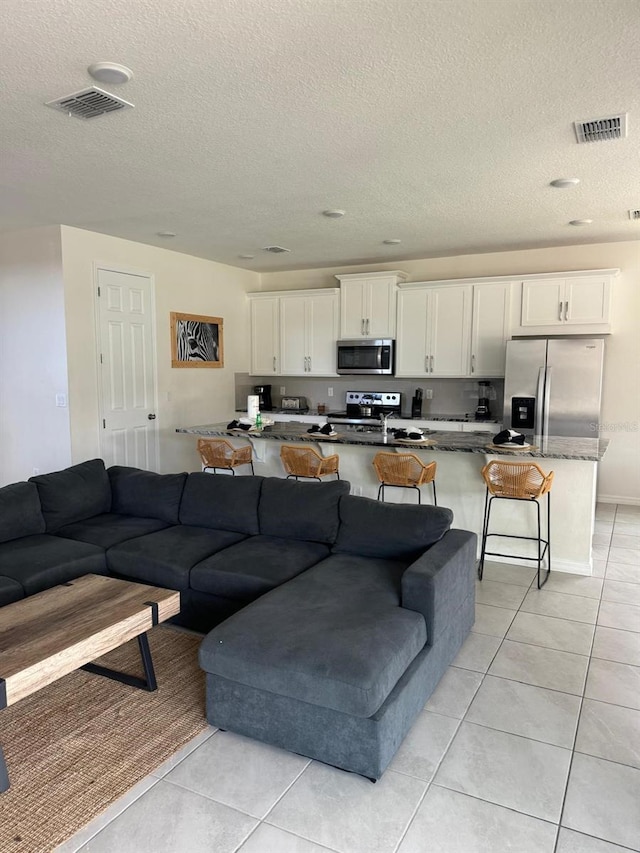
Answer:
171 311 224 367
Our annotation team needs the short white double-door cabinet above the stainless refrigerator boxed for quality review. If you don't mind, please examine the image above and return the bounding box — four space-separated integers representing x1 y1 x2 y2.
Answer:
520 276 611 332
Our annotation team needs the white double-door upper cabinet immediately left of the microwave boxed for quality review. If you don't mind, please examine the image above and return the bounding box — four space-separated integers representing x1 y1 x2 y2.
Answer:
280 288 338 376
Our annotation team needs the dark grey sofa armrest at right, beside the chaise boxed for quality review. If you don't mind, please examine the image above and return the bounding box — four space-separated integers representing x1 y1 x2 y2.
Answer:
402 530 477 646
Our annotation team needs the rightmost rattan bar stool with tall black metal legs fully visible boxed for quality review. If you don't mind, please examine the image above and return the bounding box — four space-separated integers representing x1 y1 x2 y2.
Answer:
478 459 553 589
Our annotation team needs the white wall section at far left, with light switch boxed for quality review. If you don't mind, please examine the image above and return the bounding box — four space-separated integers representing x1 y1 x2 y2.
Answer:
0 226 71 485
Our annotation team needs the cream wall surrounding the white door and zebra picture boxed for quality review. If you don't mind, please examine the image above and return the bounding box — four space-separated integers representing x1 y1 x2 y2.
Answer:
62 226 260 472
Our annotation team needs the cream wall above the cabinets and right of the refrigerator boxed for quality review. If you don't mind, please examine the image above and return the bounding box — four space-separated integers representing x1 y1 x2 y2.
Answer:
261 241 640 503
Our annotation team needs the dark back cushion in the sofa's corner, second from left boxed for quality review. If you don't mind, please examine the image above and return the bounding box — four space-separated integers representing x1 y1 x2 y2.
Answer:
29 459 111 533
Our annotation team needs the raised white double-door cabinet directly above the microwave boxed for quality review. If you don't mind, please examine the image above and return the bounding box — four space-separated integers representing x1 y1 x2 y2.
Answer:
336 270 407 339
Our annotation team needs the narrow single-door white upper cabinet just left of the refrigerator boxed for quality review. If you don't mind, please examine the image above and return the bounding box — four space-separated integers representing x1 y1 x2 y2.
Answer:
469 282 511 377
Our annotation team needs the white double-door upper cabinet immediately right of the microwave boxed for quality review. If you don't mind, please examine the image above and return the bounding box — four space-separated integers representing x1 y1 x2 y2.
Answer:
396 285 473 377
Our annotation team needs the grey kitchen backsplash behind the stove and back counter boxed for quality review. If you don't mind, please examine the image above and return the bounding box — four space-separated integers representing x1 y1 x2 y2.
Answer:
235 373 504 418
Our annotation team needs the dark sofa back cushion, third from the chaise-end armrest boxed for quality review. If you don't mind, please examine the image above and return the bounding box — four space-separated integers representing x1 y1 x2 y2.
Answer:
180 473 264 535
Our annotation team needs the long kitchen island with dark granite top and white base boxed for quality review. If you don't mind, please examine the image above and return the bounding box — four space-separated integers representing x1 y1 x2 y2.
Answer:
177 418 608 575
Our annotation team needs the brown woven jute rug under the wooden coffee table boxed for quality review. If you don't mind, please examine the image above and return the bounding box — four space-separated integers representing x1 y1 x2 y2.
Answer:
0 625 207 853
